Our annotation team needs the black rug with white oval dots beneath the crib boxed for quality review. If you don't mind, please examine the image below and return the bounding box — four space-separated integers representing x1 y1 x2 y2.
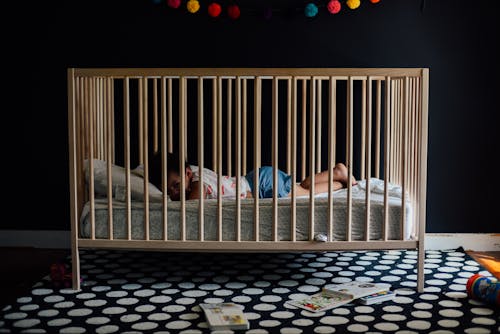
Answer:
0 249 500 334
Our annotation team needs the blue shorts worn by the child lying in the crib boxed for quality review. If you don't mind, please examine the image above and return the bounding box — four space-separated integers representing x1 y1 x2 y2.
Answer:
245 166 292 198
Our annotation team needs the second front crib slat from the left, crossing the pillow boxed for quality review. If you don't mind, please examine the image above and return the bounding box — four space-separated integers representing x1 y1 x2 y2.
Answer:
104 77 113 240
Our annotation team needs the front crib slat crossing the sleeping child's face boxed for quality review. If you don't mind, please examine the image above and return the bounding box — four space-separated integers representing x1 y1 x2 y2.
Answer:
179 76 187 241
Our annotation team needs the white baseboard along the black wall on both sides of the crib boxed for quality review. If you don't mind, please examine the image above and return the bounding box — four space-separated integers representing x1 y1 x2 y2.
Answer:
0 230 500 252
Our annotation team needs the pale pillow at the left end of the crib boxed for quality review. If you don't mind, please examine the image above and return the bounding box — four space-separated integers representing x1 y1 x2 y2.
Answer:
83 159 168 202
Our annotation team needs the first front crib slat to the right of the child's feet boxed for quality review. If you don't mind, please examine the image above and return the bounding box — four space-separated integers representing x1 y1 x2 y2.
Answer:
365 77 373 241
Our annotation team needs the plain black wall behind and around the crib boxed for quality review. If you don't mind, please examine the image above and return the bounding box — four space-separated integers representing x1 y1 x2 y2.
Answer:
4 0 500 232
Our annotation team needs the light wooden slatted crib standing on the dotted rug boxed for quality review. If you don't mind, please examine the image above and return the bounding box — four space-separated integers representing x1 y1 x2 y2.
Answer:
68 68 429 291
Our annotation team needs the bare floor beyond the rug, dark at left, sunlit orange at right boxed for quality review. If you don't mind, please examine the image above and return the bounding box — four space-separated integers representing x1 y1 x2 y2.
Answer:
0 247 500 309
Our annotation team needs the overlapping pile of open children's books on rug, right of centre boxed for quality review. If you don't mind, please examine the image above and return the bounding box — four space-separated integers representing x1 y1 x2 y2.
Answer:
287 282 392 312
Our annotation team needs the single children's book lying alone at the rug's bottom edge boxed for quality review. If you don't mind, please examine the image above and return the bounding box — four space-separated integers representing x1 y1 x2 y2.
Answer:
200 303 250 330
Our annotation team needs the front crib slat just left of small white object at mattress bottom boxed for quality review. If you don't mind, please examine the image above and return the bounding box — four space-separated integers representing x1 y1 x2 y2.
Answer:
309 77 316 240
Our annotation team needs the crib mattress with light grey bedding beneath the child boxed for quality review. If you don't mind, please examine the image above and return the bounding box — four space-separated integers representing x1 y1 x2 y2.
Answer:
80 179 415 241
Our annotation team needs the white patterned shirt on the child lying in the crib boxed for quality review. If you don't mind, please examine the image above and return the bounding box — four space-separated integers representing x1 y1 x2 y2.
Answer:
189 165 251 199
